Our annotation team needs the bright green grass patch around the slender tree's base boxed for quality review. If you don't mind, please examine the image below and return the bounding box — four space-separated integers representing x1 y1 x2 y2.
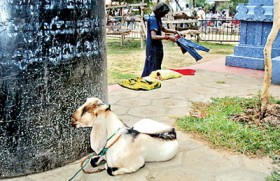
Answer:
177 96 280 156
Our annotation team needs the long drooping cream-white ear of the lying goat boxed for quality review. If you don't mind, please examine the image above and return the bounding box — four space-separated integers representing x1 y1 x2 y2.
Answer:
90 114 107 154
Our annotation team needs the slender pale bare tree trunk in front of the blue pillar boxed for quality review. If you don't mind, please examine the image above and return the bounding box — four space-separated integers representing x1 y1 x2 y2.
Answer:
261 0 280 116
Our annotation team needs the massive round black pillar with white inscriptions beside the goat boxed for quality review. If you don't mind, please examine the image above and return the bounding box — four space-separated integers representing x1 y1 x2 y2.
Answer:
0 0 107 178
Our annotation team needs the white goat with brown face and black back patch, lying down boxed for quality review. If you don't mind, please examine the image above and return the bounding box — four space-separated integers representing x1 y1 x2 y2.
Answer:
71 98 178 176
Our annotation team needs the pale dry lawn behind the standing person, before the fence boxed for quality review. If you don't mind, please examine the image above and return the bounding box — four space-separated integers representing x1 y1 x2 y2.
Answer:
107 39 234 85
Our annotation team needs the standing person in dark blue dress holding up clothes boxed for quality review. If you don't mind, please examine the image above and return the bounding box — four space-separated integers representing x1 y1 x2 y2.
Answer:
141 2 178 77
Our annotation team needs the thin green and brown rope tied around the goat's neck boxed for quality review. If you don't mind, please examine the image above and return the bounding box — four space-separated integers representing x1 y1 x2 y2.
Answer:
69 128 122 181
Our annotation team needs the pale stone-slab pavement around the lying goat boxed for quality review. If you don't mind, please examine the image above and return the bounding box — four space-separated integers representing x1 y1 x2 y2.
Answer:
4 59 280 181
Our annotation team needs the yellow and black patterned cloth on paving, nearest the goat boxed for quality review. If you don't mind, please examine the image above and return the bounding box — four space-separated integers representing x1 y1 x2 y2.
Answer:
119 78 161 91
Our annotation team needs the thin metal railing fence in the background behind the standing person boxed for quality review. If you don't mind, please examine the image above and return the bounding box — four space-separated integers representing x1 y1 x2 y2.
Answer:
107 19 240 42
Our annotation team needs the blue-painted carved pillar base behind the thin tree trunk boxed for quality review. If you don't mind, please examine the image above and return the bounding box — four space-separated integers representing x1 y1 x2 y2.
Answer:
226 0 280 70
